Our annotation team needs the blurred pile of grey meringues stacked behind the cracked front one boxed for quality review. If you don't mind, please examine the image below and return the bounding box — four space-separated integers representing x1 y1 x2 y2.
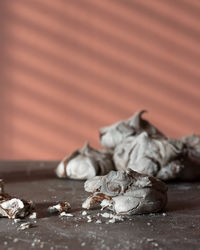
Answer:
56 110 200 181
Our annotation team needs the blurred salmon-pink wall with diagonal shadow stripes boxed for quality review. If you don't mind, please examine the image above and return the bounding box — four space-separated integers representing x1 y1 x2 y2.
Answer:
0 0 200 160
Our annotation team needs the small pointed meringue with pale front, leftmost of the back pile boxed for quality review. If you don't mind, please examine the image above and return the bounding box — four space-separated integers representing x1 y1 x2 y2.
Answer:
56 143 114 180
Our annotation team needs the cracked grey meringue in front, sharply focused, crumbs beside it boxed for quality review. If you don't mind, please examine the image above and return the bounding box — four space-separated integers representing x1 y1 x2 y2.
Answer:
82 169 167 215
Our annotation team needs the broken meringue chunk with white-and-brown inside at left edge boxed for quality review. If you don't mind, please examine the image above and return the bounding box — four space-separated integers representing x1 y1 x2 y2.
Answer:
0 180 34 219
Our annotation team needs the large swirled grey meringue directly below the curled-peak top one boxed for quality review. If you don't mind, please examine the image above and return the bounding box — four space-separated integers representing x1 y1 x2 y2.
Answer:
113 132 187 180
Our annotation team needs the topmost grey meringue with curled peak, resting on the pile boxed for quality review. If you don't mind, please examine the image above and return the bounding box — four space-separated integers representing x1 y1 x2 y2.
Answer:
100 110 165 149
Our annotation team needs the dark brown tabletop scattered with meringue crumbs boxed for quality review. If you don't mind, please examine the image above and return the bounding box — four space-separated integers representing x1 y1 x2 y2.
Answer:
0 162 200 250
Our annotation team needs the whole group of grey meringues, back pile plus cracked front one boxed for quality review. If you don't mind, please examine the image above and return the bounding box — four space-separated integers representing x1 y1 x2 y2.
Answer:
56 110 200 215
